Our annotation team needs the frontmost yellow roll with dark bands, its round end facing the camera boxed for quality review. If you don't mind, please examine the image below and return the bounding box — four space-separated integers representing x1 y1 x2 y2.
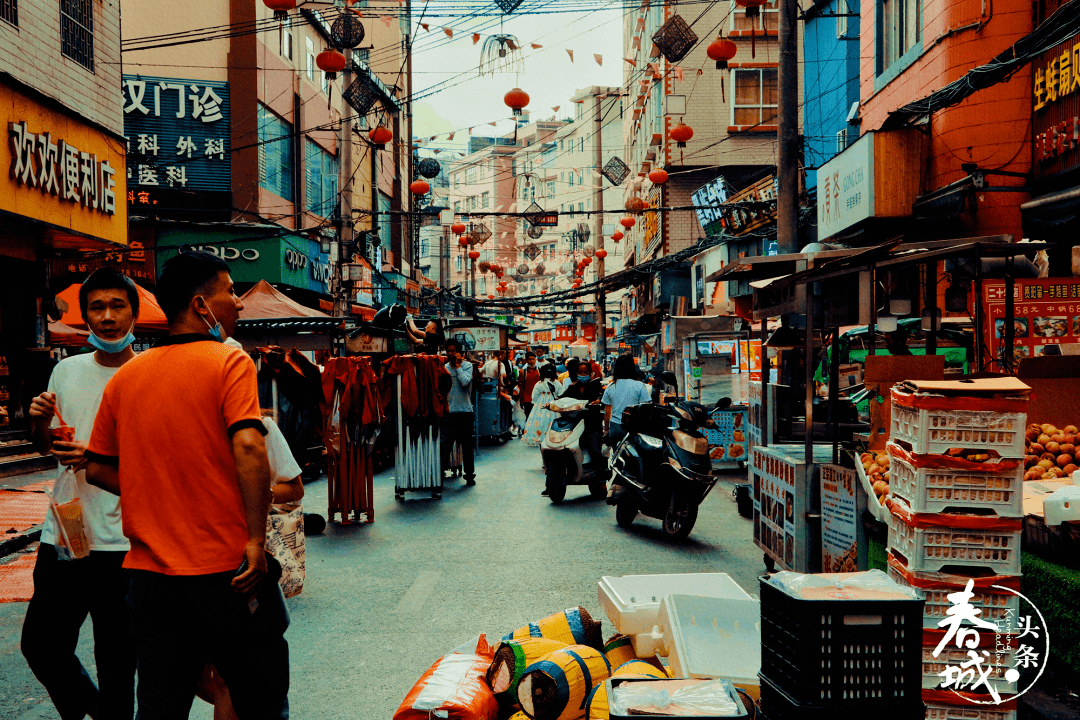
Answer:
517 646 611 720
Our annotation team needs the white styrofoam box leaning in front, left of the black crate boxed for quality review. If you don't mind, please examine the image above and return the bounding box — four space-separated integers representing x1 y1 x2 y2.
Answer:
659 595 761 695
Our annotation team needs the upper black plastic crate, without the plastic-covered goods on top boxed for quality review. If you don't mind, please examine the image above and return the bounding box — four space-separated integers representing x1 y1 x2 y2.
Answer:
760 580 923 708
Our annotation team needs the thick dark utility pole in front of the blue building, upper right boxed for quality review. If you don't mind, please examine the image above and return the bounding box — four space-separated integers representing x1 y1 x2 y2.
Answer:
777 0 799 255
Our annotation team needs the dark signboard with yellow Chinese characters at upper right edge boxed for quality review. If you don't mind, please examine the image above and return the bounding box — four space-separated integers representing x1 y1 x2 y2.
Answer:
1031 35 1080 178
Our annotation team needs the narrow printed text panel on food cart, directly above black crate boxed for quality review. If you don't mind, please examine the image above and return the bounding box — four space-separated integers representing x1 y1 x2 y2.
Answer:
820 464 868 572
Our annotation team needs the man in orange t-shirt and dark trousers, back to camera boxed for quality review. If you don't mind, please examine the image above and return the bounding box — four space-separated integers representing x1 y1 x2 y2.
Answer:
85 253 288 720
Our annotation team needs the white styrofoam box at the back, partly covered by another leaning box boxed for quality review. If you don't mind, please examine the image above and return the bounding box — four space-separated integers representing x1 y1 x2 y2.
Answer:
597 572 751 657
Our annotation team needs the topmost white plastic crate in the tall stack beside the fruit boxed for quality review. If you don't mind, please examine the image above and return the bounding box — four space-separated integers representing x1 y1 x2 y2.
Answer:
890 391 1027 458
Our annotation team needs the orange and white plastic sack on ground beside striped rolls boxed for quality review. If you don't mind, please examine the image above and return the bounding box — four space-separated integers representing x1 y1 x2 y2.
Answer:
394 634 499 720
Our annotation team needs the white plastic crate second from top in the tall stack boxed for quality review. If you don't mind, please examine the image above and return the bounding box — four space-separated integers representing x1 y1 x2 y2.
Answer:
889 444 1024 517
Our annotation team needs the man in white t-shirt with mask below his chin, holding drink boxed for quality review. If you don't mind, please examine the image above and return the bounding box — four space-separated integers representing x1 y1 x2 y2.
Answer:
22 269 138 720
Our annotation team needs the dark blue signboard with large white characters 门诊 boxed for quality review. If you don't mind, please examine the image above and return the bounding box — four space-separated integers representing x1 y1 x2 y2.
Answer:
121 74 232 217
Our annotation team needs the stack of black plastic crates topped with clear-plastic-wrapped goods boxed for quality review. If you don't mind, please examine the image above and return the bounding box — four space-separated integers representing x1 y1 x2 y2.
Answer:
760 571 923 720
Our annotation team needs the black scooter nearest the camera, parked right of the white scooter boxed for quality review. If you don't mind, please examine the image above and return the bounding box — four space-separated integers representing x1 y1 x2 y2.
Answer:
608 372 731 540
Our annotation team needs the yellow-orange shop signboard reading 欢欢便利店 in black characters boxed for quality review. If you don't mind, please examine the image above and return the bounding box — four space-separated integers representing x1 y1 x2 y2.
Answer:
0 84 127 245
